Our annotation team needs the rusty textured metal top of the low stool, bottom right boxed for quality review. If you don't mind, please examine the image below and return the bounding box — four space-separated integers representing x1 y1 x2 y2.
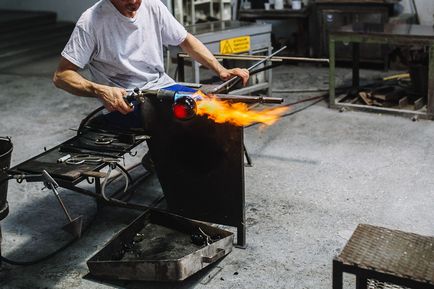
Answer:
337 224 434 284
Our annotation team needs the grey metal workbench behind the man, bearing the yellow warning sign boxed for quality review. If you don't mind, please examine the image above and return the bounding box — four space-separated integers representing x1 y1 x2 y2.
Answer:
170 21 272 95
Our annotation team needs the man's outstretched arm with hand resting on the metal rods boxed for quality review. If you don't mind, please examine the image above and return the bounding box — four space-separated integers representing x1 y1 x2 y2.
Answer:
180 33 249 85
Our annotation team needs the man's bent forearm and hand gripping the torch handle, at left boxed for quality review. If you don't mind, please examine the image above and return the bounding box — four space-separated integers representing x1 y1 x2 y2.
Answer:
53 57 133 114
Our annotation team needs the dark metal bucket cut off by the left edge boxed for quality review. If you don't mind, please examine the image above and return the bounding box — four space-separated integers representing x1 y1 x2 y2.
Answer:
0 137 13 220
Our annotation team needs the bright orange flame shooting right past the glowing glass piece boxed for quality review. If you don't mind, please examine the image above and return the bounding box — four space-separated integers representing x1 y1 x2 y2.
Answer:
193 91 288 126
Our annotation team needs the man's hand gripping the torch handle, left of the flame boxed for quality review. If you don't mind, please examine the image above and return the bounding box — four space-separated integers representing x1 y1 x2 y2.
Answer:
97 85 133 114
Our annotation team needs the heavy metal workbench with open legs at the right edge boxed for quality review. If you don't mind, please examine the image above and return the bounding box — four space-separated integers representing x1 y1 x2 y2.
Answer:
329 23 434 119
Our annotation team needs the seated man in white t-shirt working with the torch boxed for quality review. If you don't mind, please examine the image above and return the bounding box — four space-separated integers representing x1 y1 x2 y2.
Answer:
53 0 249 119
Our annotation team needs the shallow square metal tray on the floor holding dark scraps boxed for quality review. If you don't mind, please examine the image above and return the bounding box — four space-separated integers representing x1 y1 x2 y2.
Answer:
87 211 234 281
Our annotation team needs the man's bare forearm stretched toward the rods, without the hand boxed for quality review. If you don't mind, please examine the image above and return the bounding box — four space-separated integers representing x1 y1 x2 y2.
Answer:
181 33 225 75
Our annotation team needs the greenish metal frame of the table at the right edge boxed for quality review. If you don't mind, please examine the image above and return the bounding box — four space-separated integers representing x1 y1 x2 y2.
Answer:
329 25 434 119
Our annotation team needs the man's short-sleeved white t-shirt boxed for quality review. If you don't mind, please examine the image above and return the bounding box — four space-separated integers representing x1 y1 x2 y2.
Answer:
62 0 187 89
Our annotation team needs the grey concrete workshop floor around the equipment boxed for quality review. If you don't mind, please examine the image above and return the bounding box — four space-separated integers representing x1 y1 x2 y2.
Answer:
0 58 434 289
